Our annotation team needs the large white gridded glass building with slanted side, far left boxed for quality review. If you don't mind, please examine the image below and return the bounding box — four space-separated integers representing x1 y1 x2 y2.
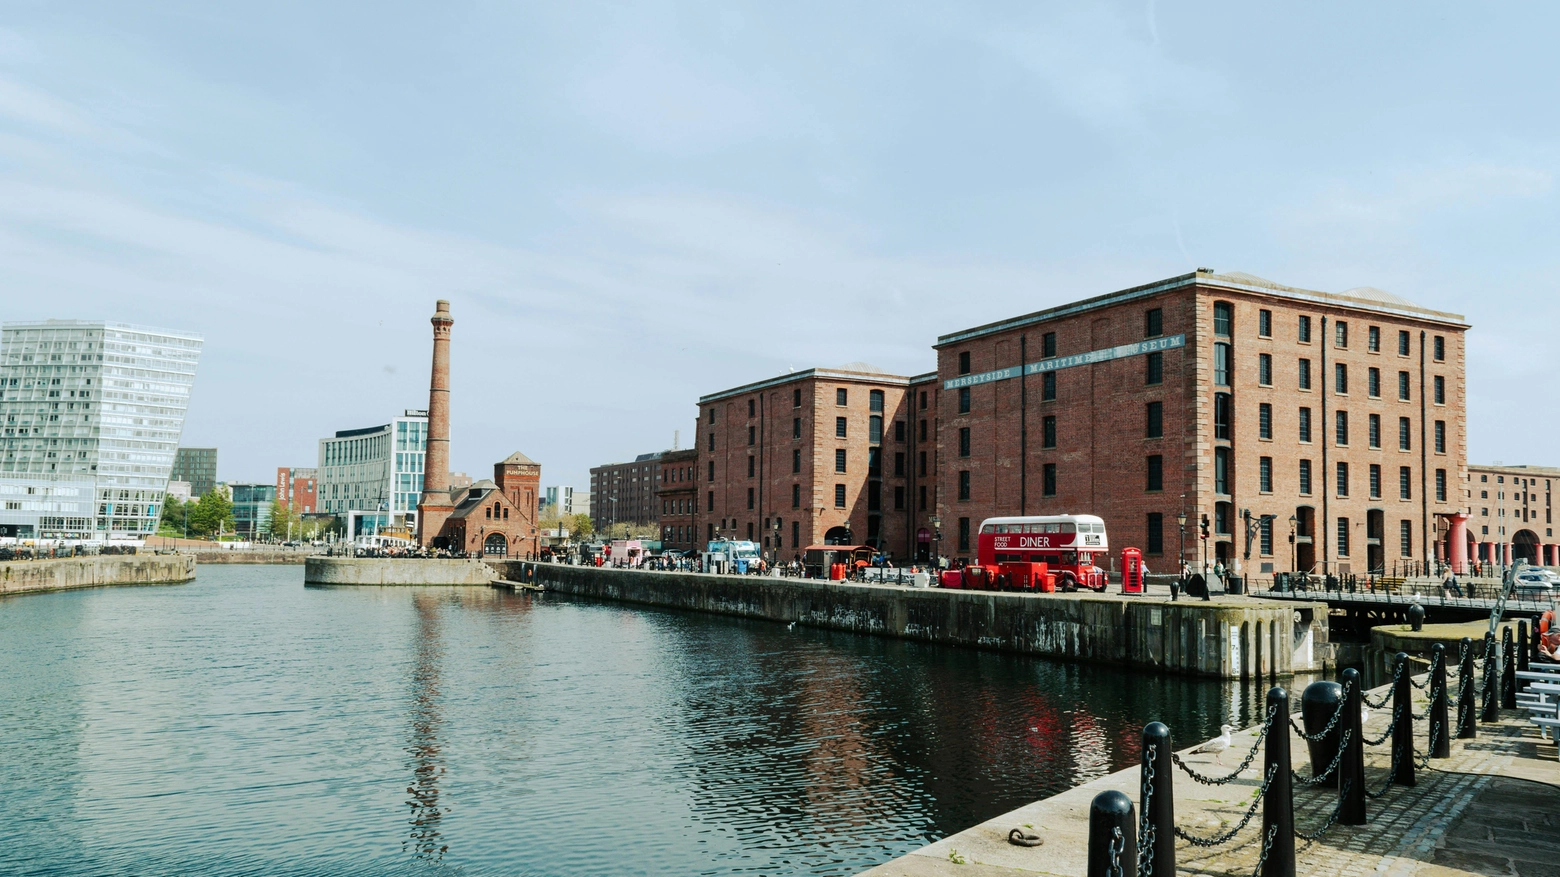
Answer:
0 320 201 541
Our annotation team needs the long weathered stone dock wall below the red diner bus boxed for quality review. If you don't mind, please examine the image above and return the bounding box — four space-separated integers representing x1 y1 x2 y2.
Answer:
491 560 1331 679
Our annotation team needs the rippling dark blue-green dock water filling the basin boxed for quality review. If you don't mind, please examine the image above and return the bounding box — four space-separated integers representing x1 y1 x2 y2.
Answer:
0 566 1291 877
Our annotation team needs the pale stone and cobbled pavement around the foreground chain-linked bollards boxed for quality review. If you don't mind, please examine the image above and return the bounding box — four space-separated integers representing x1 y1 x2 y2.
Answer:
867 677 1560 877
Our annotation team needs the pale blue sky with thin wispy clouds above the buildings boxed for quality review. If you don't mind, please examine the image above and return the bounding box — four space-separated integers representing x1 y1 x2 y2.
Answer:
0 0 1560 487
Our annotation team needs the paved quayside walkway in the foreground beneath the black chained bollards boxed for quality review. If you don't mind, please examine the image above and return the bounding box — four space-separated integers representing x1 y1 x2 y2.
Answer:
863 644 1560 877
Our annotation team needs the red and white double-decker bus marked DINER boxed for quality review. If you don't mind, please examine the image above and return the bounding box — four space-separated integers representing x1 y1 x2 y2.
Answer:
977 515 1111 591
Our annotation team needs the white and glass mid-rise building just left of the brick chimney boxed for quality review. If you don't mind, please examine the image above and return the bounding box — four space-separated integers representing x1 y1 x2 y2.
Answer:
318 409 427 537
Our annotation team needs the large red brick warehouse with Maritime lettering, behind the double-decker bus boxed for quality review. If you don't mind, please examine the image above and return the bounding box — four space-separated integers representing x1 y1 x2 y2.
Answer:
936 270 1468 573
